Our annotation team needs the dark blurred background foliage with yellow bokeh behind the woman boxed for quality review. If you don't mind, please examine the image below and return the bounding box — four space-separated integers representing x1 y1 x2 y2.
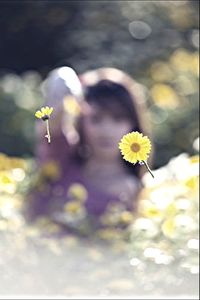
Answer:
0 1 199 168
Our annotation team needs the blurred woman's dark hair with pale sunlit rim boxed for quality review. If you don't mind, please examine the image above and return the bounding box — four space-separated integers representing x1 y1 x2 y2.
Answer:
79 68 152 177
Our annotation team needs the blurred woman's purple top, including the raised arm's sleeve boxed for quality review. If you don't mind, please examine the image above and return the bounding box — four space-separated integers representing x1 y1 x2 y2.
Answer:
27 125 134 223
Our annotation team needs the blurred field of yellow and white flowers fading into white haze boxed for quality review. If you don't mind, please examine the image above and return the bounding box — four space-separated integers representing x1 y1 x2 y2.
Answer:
0 153 199 298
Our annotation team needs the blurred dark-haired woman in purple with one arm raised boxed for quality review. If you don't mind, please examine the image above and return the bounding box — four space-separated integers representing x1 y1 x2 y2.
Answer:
25 68 152 233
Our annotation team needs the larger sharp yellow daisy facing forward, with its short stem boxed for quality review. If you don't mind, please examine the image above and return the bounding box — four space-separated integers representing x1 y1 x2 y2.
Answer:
119 131 154 177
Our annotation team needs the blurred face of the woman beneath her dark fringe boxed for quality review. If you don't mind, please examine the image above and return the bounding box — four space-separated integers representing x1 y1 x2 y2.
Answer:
82 104 133 160
